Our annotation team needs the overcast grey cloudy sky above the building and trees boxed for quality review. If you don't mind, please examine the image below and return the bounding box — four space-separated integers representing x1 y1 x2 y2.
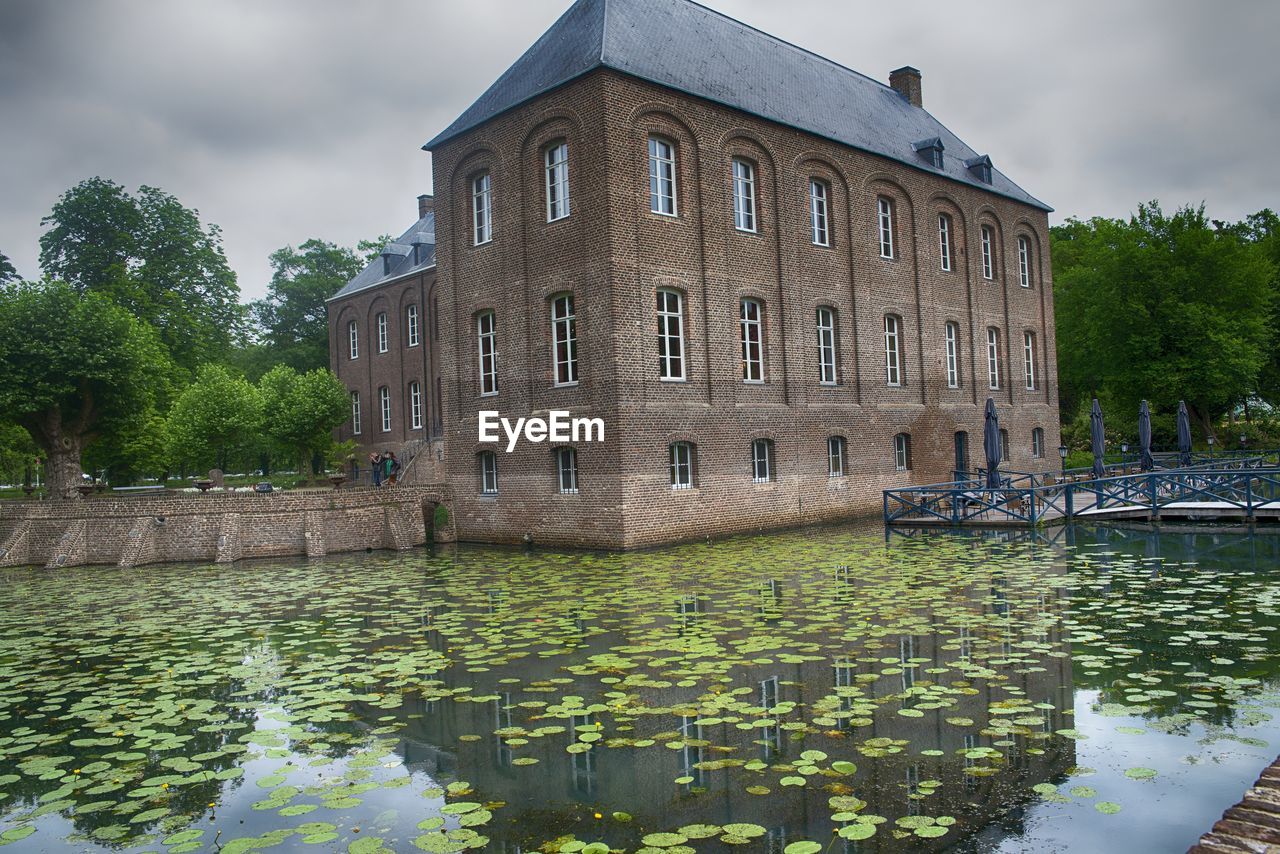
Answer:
0 0 1280 300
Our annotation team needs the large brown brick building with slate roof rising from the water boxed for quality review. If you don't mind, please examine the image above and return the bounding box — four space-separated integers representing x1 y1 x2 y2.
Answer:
330 0 1059 547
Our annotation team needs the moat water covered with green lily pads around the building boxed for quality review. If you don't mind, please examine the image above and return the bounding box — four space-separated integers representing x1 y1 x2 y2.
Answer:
0 528 1280 854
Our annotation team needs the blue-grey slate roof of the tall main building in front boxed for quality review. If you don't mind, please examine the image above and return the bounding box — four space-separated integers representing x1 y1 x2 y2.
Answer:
422 0 1052 210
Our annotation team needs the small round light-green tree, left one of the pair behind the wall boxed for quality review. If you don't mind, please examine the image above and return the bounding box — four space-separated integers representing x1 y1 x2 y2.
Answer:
166 365 262 471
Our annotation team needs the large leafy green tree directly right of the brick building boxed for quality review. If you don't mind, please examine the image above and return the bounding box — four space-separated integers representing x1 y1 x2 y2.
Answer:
1052 202 1275 431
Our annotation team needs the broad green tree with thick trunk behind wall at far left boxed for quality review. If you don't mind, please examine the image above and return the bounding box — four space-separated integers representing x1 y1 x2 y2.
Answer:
0 282 168 498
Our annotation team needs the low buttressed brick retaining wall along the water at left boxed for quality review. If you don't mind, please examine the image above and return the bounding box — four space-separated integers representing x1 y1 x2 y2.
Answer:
0 487 456 568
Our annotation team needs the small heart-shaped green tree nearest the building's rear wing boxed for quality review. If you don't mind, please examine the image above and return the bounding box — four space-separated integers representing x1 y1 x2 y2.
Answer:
259 365 351 474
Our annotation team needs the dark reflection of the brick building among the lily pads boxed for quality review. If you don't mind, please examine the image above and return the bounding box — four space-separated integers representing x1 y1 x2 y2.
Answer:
348 563 1075 851
